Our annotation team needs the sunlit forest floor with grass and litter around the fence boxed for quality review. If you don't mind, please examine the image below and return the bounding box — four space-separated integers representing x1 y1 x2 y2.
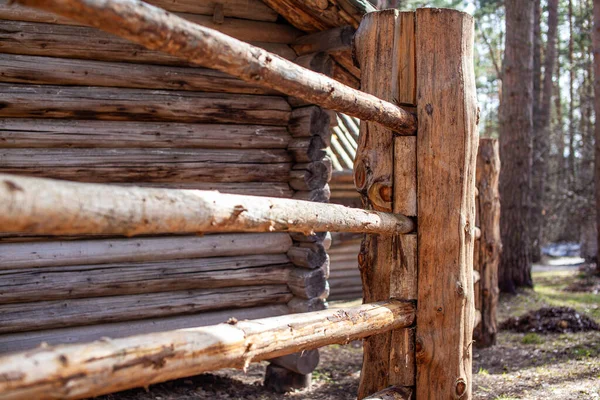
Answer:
102 265 600 400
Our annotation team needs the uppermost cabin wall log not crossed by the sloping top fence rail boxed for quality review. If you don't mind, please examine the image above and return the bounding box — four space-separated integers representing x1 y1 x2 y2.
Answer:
0 84 290 125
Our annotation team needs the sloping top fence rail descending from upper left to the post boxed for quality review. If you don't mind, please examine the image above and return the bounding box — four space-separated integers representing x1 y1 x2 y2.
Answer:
14 0 416 134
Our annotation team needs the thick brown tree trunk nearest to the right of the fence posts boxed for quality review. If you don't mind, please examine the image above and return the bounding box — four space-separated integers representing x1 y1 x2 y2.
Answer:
499 0 534 293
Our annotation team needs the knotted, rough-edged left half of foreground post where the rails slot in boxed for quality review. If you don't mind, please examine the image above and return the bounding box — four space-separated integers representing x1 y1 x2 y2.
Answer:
354 10 417 399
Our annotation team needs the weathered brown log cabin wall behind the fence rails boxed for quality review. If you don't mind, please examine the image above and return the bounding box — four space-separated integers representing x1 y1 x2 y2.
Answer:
0 0 331 356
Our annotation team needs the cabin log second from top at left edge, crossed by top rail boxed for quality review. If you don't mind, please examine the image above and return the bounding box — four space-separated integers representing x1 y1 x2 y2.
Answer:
0 20 296 62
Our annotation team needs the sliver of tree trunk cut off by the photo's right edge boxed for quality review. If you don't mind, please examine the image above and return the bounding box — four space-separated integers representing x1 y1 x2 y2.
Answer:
592 0 600 274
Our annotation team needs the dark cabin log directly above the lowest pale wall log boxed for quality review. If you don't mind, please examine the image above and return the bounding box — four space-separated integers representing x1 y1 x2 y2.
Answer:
0 285 292 334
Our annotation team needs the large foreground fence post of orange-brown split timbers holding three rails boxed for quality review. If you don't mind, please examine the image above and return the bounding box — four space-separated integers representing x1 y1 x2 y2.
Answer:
354 9 477 400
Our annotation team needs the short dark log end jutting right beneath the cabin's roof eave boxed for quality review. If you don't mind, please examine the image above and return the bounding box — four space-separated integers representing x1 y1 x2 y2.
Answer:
291 26 355 56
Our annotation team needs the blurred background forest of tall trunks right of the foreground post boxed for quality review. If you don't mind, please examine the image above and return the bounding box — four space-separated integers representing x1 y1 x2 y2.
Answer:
376 0 597 292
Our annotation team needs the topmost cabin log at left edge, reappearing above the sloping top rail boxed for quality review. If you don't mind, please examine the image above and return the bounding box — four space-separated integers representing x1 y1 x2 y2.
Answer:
0 0 303 44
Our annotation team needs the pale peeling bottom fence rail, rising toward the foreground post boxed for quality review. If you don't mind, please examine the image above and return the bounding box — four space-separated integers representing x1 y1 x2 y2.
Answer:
0 301 415 400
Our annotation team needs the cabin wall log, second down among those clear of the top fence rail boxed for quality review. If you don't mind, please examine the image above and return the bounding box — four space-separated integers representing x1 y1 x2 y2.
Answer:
0 118 291 150
